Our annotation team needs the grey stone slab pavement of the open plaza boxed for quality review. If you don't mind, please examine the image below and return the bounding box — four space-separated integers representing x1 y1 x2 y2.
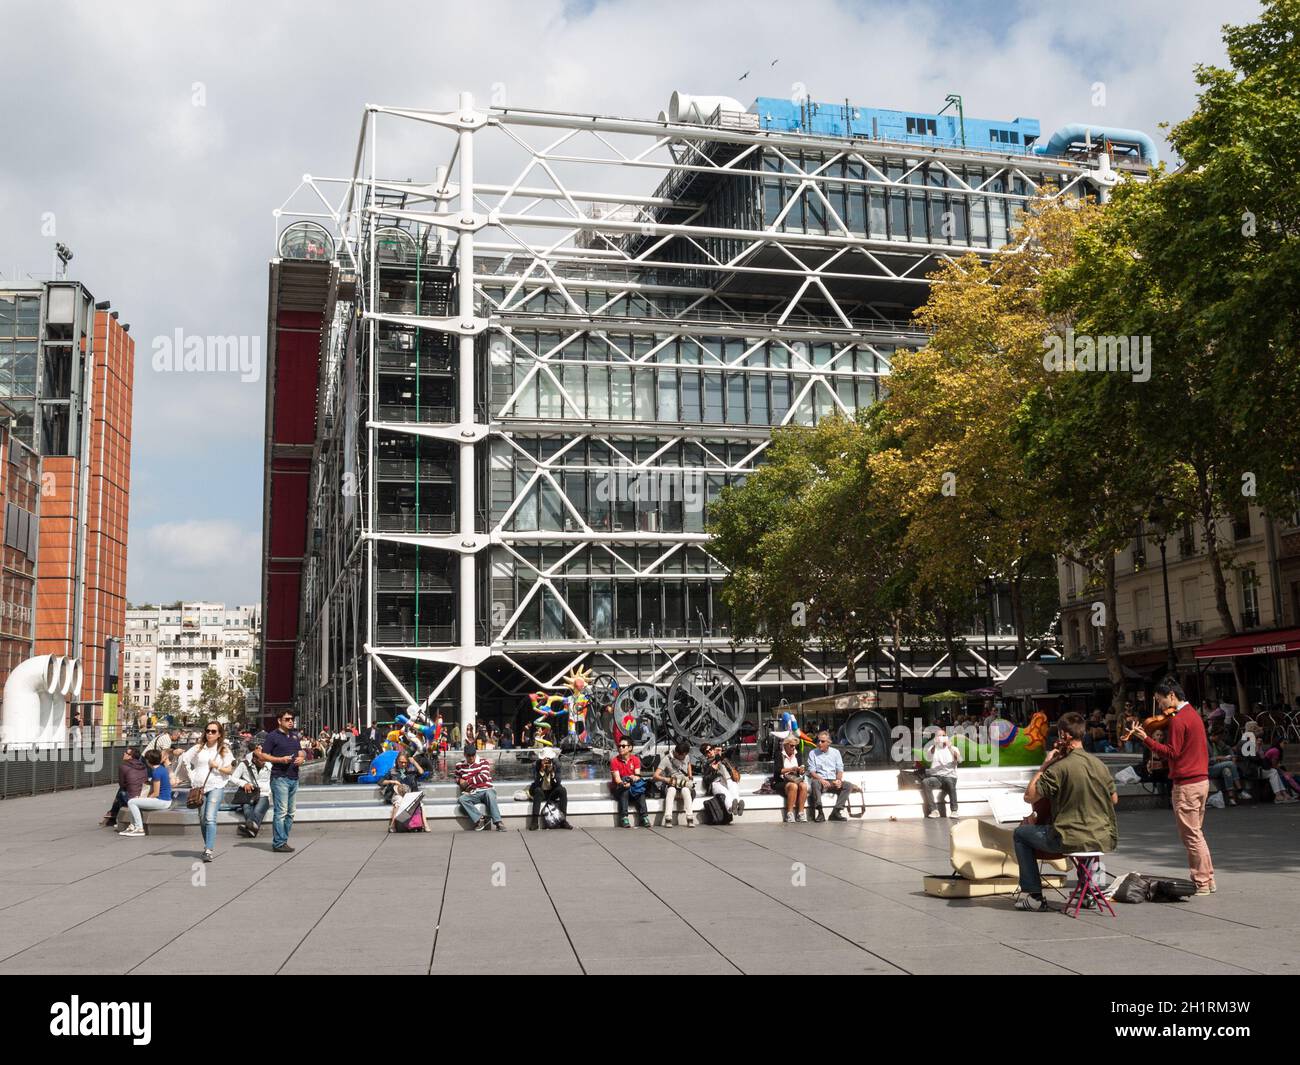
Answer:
0 788 1300 975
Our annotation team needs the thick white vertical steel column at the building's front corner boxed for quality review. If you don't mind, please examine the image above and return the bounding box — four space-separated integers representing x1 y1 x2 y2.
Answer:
456 92 478 731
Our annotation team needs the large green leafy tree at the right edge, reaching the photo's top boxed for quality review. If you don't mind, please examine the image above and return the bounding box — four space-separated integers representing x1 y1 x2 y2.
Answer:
1040 0 1300 705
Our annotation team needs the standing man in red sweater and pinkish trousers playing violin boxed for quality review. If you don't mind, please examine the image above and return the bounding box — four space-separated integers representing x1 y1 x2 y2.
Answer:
1134 677 1217 895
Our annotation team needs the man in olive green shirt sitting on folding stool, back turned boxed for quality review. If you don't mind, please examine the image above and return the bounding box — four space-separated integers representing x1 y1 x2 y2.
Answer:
1015 714 1119 913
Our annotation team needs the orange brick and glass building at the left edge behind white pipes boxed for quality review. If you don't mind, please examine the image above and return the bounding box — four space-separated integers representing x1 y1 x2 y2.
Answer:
0 281 135 724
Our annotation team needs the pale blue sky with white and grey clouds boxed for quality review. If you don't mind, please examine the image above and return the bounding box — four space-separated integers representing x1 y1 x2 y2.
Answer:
0 0 1258 603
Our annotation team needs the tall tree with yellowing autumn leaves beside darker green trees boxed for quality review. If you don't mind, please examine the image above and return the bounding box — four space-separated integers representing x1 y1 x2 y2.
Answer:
872 198 1097 658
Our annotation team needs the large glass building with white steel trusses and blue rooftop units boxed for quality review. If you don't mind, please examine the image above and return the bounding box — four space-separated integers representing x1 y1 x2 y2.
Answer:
264 94 1154 722
